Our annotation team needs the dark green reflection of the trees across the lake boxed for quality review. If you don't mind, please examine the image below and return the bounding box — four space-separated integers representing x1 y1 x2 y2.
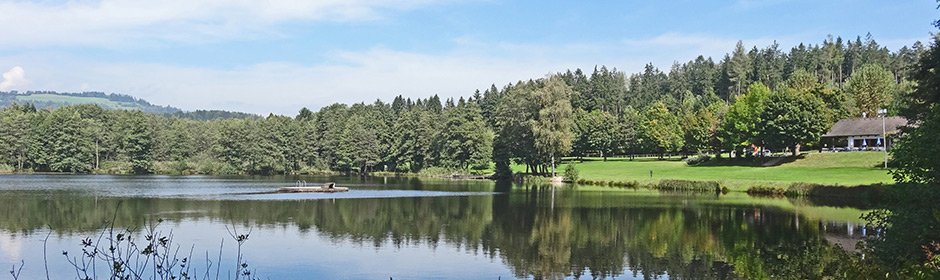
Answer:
0 186 940 279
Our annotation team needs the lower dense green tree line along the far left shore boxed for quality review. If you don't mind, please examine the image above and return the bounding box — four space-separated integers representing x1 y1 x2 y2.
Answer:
0 96 493 174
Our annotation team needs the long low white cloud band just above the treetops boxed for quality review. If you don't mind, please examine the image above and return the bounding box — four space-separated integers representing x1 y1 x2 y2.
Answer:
0 33 916 114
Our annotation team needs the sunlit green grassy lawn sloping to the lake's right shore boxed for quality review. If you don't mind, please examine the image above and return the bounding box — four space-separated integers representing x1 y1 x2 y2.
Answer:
540 152 893 190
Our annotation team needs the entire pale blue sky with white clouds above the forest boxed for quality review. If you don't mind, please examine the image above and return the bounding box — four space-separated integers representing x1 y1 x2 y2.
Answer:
0 0 940 115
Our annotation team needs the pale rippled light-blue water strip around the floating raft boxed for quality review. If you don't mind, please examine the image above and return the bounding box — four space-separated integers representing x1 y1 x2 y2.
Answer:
0 174 493 200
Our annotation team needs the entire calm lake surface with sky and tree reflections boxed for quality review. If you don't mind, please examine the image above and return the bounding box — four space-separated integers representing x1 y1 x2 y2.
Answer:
0 175 869 279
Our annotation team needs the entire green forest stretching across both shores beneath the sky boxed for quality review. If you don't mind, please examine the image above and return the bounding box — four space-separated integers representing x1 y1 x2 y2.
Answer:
0 35 929 179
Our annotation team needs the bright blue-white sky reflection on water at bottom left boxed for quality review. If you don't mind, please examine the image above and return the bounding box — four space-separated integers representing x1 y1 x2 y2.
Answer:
0 219 512 279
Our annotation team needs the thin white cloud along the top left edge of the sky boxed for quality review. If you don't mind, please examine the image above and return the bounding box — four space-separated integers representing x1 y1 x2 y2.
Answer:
0 0 444 48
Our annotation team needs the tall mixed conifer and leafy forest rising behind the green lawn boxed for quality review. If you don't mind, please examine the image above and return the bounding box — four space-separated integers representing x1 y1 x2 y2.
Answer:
560 35 926 162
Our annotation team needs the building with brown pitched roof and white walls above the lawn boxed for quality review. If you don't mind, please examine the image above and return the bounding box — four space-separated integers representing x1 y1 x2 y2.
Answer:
822 117 907 151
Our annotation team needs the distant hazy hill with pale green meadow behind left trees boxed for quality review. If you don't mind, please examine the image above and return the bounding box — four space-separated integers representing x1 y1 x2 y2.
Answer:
0 91 259 120
